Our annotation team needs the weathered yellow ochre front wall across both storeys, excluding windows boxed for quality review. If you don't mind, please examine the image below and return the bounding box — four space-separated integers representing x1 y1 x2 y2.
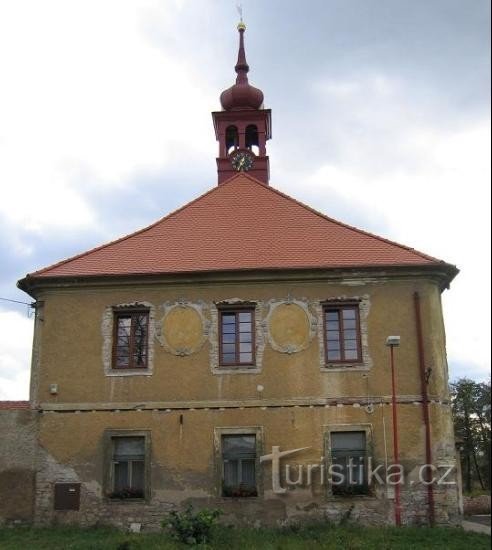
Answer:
31 277 457 528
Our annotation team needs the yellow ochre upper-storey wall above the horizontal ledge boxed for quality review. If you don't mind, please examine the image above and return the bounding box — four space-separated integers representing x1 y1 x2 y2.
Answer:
32 280 447 405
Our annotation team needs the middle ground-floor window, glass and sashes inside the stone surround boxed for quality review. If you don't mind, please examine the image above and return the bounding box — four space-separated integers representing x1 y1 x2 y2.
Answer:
221 434 258 497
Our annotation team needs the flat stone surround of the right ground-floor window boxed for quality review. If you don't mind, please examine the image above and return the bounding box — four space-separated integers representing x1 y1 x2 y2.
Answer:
324 424 374 500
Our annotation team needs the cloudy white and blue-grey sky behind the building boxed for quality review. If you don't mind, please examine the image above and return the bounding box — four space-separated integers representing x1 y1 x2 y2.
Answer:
0 0 491 399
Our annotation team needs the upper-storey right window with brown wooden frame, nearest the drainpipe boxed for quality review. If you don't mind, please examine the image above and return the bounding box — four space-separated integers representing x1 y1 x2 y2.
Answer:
323 304 362 363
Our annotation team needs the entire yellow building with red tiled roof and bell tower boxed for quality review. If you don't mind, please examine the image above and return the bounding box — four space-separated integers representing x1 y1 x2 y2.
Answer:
3 24 458 528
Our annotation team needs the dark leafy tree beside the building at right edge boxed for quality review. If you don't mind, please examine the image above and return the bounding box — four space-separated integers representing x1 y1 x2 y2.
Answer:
451 378 491 492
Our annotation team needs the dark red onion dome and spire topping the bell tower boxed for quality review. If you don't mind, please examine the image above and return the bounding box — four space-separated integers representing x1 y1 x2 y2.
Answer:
220 19 263 111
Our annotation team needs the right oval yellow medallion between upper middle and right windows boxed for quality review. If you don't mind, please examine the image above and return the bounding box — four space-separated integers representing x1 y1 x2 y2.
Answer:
268 302 313 353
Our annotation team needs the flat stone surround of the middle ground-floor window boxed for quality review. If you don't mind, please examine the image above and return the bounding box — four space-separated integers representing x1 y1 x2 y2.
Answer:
214 426 263 500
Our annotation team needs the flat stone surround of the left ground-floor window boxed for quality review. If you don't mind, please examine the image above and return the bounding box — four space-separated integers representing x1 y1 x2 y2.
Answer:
103 430 151 502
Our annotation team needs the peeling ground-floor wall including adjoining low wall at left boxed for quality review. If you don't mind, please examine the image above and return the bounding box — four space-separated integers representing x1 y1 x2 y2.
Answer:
0 404 459 530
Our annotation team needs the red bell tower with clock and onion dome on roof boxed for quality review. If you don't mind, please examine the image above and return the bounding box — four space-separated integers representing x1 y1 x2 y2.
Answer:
212 20 272 185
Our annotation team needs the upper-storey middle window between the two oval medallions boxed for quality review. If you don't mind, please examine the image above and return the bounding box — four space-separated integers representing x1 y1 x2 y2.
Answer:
219 308 255 366
